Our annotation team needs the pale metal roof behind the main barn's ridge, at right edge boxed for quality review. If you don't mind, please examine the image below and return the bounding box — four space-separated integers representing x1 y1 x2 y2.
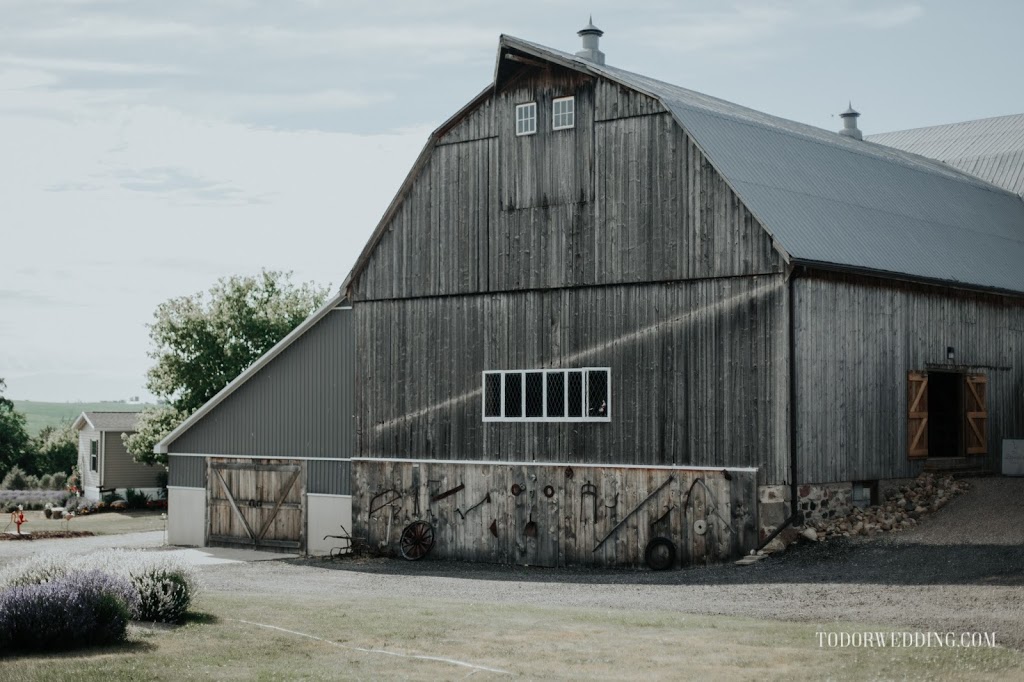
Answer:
867 114 1024 196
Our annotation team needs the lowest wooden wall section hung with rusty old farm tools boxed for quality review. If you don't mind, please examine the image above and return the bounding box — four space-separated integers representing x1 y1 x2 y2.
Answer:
352 460 758 566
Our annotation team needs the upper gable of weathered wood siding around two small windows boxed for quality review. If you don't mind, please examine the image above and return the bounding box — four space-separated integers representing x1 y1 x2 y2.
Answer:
352 69 782 300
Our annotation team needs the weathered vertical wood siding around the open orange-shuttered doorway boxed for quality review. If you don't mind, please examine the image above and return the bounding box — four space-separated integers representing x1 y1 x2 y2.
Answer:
796 274 1024 482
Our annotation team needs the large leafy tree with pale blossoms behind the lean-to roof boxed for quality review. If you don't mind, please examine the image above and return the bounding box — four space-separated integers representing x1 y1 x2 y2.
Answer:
125 270 328 464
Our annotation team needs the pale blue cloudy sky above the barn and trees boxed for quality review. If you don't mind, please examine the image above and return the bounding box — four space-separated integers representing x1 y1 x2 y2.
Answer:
0 0 1024 401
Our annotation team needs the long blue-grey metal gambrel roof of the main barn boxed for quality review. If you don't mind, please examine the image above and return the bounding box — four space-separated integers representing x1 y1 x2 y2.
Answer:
499 36 1024 293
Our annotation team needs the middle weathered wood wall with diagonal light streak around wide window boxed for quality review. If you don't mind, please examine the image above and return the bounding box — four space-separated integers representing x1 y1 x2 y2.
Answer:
353 275 788 482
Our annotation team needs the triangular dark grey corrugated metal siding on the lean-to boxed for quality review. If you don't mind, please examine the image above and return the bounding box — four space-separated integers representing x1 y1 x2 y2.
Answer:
169 309 355 458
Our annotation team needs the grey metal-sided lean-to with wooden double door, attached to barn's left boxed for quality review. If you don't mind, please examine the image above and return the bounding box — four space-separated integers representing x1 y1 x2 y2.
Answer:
155 296 354 554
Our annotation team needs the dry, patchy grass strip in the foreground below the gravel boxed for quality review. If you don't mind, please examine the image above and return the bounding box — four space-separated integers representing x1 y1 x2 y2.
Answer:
0 586 1024 682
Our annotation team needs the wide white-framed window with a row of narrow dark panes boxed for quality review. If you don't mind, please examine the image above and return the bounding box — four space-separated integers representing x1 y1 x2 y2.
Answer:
483 367 611 422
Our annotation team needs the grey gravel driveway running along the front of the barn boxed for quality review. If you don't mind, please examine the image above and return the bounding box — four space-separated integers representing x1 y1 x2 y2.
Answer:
204 478 1024 649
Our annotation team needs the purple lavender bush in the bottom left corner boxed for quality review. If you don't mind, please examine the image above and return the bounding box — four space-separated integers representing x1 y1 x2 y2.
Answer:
0 570 139 653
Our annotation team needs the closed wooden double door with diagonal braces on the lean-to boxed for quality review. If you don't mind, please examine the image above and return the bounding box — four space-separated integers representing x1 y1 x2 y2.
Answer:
207 460 305 549
